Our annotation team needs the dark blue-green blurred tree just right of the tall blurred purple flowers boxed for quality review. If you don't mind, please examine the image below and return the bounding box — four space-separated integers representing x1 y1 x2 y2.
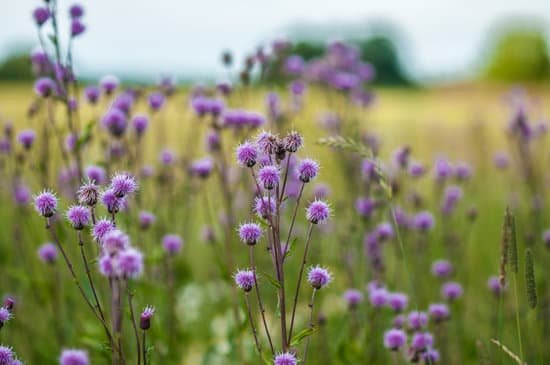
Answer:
355 35 411 86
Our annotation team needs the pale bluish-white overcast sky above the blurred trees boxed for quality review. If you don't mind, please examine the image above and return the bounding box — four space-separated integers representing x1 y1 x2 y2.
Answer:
0 0 550 78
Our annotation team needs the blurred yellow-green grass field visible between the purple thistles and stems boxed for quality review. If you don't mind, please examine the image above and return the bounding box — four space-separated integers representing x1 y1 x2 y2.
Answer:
0 84 550 364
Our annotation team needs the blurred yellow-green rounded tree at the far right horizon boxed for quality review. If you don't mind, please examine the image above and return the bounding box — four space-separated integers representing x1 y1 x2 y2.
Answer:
486 29 550 82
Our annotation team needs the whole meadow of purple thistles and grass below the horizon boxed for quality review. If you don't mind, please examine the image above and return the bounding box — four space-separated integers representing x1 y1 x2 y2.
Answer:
0 1 550 365
